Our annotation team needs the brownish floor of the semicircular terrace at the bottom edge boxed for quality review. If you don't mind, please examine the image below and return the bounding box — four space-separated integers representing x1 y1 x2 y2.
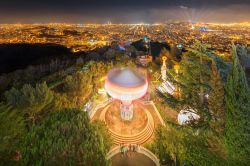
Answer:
111 152 155 166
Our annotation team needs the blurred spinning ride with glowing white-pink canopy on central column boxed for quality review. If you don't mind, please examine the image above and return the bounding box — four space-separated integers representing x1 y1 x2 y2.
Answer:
105 68 148 120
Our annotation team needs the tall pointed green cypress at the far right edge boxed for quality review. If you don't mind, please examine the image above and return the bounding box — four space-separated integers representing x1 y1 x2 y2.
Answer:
225 45 250 165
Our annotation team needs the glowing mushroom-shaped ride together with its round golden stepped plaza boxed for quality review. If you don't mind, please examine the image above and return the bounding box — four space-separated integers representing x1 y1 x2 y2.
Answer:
93 68 162 145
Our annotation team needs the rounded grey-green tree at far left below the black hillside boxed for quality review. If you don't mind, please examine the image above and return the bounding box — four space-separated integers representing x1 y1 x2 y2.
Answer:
5 82 54 124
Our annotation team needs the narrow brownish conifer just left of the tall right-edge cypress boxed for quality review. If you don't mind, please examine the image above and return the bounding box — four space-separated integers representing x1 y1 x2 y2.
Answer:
208 61 225 134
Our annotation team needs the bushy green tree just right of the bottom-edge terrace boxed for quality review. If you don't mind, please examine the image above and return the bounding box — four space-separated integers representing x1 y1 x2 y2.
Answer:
154 125 223 166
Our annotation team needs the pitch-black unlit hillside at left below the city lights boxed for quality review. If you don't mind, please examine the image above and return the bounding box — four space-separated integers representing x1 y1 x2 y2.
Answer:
0 44 70 73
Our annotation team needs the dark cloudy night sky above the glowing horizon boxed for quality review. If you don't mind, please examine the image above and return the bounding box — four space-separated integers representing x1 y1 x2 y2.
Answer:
0 0 250 23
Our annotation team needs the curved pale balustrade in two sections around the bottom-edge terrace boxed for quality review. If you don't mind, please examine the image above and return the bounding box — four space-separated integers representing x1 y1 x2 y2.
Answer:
107 146 160 166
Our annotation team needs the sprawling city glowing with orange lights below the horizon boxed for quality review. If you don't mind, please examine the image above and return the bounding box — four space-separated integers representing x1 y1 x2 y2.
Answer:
0 22 250 56
